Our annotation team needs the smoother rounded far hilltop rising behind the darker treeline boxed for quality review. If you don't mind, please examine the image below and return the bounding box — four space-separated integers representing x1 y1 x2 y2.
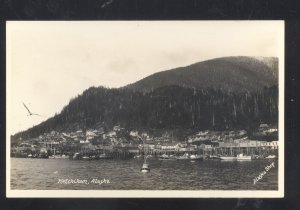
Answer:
125 56 278 92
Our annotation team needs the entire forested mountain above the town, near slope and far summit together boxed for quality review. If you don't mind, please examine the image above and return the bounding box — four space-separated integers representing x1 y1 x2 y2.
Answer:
13 57 278 139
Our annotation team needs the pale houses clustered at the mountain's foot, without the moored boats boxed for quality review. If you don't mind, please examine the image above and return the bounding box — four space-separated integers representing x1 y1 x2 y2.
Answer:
12 125 278 157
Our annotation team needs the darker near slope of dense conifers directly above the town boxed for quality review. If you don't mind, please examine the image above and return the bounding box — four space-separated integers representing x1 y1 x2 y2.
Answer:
14 86 278 139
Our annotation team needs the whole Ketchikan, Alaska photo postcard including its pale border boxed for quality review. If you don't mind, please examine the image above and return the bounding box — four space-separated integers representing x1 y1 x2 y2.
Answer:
6 21 285 198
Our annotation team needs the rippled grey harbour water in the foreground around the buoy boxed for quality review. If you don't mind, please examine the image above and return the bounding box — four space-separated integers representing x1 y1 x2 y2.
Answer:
11 158 278 190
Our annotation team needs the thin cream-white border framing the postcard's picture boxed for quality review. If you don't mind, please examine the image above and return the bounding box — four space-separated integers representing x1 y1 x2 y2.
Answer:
6 20 285 198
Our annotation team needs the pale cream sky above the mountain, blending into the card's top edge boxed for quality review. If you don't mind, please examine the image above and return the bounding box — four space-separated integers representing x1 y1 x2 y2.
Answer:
6 21 284 134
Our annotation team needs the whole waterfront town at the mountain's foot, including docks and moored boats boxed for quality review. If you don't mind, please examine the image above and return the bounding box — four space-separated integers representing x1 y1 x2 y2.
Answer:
11 124 278 159
